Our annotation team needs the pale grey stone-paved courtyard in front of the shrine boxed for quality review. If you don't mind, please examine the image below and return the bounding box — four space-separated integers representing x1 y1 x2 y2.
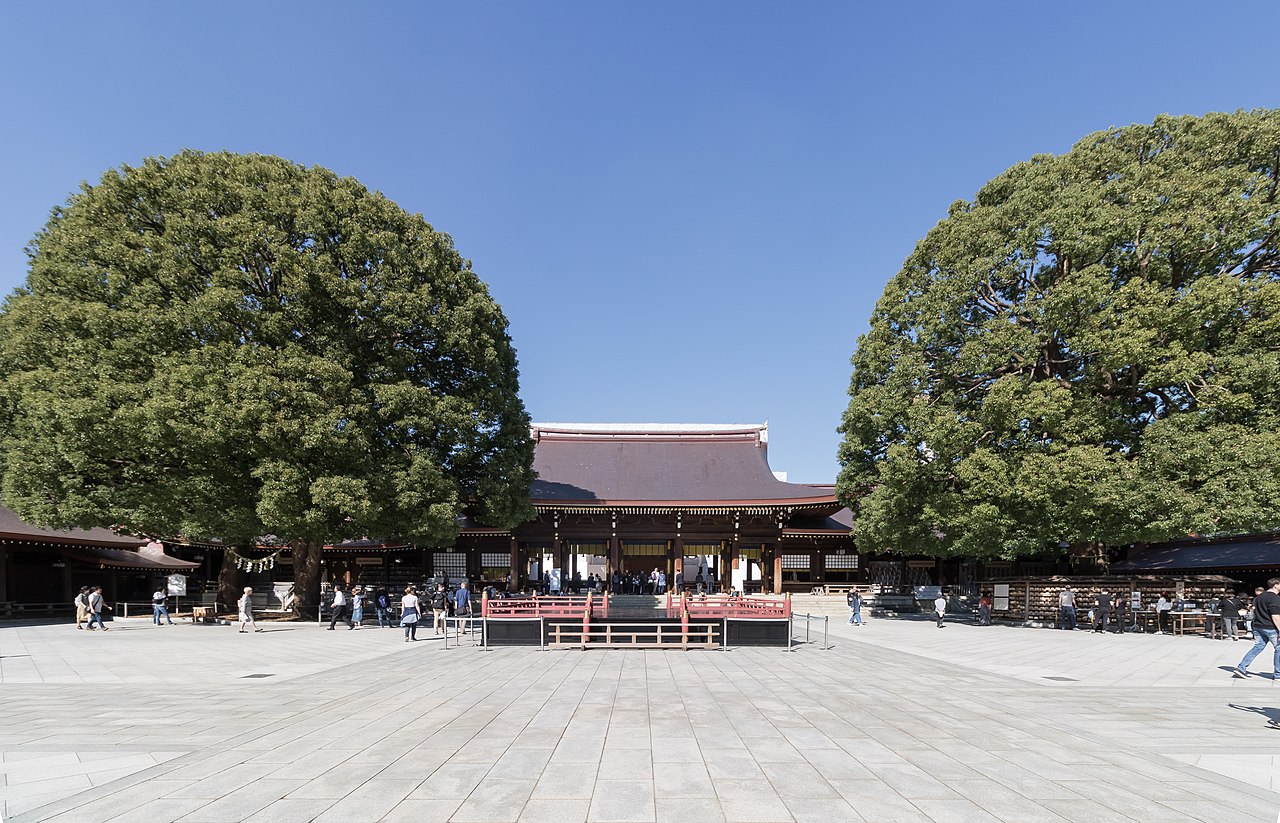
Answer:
0 619 1280 823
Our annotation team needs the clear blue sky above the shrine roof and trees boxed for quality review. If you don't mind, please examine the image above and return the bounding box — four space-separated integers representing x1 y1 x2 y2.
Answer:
0 0 1280 483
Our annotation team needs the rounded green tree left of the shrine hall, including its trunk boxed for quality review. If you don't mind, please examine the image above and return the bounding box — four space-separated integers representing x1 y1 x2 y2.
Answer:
0 151 532 613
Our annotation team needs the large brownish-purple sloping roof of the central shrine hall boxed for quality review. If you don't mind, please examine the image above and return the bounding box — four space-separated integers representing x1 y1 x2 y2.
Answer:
530 424 835 506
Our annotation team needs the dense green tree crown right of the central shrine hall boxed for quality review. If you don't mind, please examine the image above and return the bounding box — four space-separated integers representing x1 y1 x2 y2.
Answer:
837 110 1280 557
